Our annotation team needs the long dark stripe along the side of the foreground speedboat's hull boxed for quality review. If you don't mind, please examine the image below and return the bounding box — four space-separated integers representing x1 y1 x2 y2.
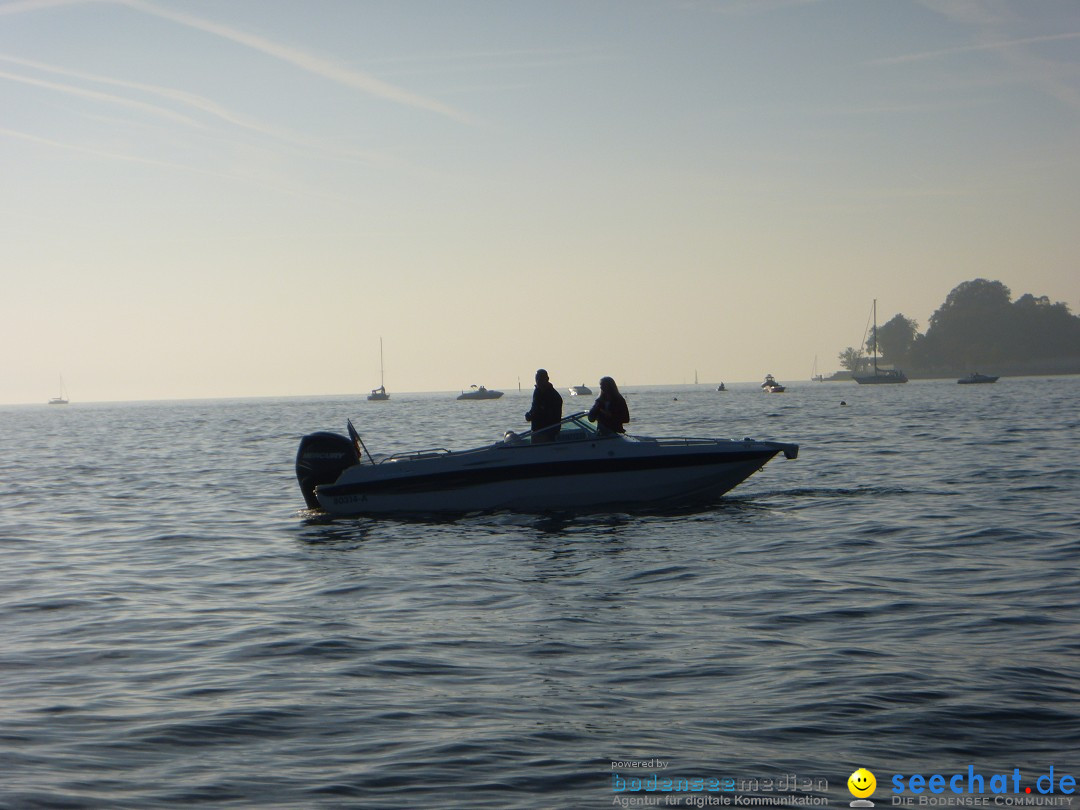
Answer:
318 448 780 498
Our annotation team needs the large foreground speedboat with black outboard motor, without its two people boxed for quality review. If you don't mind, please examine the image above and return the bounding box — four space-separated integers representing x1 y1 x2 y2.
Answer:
296 413 799 515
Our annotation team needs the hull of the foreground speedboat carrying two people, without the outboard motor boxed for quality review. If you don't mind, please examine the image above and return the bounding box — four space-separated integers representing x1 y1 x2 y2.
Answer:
315 437 798 515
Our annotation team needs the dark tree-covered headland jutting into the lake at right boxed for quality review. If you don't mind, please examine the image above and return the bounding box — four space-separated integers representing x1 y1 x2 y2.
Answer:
840 279 1080 377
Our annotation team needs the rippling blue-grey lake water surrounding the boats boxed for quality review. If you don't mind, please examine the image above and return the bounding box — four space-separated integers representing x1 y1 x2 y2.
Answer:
0 377 1080 810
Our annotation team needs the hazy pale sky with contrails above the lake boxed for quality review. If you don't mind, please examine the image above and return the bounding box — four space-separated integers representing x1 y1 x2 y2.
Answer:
0 0 1080 403
